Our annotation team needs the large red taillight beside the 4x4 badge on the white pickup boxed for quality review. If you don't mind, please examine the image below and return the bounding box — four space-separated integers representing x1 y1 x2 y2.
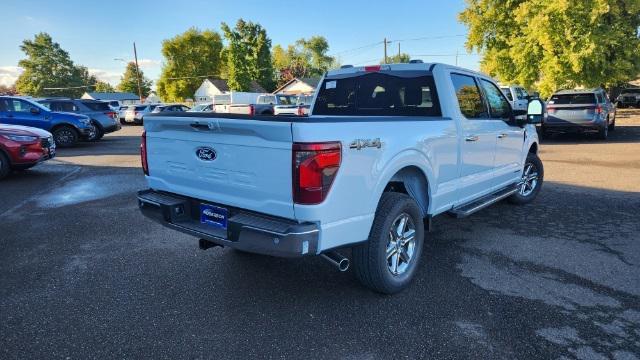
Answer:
292 142 342 205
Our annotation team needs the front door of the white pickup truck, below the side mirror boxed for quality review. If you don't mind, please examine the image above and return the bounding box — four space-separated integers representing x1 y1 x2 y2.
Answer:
480 79 524 188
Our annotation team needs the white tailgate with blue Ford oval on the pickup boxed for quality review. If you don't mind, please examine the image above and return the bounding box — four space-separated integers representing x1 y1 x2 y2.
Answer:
145 116 294 219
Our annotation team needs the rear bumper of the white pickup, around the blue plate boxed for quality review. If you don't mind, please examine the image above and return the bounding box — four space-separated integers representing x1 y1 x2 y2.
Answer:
138 190 320 257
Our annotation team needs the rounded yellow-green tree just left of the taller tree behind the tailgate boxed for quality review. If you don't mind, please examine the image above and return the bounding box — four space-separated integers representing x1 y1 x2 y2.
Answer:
157 28 222 102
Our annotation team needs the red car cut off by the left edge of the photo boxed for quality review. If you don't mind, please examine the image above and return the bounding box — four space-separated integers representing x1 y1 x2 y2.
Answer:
0 124 56 179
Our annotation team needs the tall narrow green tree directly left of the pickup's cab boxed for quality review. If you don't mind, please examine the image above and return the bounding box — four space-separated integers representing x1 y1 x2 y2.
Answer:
222 19 275 91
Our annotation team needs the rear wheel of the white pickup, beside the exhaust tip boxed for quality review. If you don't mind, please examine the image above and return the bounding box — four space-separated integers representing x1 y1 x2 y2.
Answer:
352 192 424 294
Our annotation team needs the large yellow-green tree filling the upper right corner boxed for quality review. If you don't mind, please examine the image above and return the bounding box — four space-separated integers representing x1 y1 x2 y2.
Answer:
459 0 640 96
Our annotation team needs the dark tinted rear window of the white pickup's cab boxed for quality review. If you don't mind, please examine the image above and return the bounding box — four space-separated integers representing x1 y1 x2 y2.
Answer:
313 72 442 116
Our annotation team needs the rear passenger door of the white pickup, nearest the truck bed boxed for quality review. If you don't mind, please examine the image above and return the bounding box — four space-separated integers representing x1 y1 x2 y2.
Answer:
451 73 496 204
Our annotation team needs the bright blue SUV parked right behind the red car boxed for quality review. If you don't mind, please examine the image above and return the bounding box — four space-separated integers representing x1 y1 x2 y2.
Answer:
0 96 96 147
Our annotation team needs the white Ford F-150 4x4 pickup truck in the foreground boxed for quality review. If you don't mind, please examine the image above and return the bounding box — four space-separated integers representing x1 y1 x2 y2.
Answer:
138 63 544 293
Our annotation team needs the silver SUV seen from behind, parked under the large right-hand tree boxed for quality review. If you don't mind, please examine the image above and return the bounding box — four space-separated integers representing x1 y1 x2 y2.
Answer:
541 88 616 140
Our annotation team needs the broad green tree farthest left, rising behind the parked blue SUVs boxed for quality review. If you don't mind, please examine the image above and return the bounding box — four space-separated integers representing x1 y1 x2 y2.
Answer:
15 33 96 97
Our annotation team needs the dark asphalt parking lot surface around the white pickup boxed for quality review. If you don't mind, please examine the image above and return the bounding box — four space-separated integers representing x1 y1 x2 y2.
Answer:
0 110 640 359
